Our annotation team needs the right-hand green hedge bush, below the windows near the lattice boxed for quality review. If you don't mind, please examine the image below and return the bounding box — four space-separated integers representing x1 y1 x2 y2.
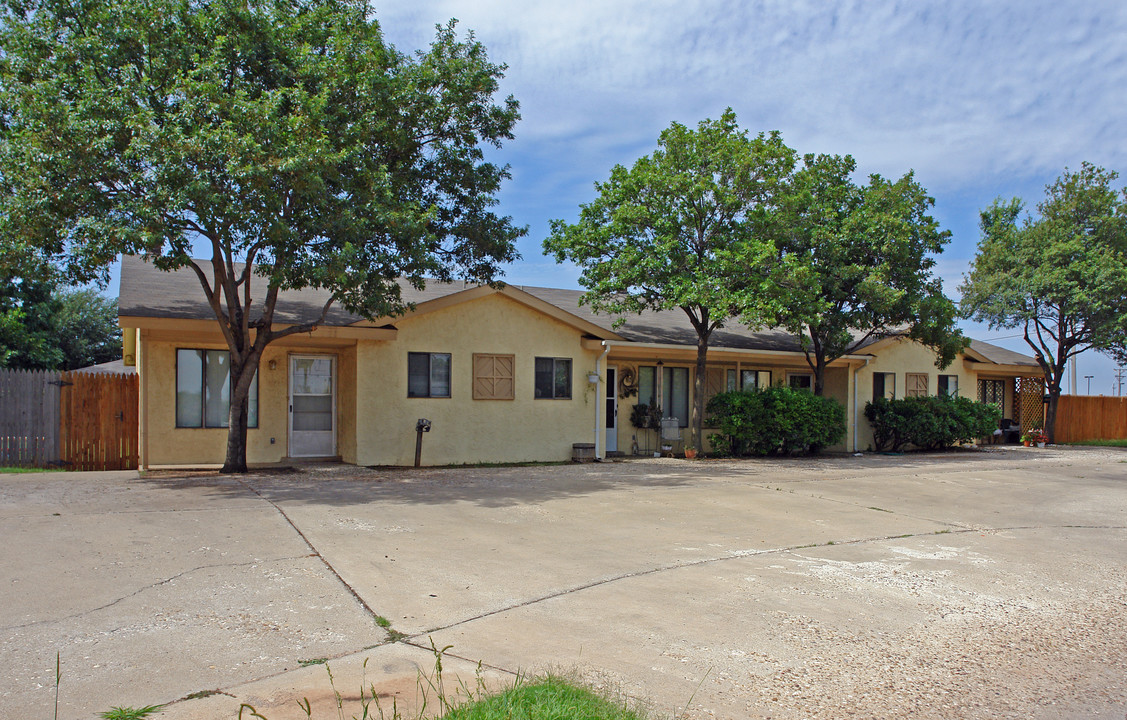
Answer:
864 395 1002 452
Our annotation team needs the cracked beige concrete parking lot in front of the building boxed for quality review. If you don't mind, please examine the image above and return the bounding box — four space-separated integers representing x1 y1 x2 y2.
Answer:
0 447 1127 720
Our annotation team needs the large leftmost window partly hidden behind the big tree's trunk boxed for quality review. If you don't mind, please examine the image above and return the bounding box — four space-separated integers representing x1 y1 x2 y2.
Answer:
176 348 258 427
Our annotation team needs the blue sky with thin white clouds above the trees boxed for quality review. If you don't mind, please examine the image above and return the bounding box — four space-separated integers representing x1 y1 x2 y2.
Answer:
374 0 1127 393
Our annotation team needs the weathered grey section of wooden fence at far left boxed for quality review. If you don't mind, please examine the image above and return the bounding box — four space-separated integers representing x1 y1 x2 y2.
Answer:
0 370 61 468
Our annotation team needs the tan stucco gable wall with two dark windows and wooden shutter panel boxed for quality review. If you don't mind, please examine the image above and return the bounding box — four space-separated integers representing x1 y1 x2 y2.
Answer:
356 295 597 465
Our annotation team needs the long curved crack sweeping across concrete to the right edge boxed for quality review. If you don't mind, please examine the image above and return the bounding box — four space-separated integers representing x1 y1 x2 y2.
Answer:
409 525 1127 635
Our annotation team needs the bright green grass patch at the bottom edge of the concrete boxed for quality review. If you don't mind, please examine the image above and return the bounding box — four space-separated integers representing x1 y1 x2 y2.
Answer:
443 676 644 720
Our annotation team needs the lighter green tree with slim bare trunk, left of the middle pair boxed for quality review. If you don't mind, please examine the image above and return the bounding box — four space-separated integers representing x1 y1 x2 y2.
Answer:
544 109 795 447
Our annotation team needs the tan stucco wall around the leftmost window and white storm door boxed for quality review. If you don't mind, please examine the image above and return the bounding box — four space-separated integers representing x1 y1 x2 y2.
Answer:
139 331 356 466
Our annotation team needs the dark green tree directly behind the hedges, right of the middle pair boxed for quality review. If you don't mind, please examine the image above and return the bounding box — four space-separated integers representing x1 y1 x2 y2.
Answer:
775 154 967 395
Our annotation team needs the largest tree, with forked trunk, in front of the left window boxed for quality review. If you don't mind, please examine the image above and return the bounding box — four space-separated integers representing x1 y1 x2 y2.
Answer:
0 0 524 471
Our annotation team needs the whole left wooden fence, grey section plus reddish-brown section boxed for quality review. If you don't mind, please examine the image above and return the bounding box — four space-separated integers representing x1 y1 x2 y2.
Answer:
0 370 137 470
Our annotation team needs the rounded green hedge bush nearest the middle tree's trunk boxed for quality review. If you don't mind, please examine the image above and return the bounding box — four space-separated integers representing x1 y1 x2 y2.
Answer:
706 385 845 455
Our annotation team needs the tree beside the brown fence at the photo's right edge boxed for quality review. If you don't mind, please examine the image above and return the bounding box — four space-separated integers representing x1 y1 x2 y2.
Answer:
960 162 1127 439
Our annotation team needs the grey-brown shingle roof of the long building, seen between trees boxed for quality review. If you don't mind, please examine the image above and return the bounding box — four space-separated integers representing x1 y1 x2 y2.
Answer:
118 256 1036 365
